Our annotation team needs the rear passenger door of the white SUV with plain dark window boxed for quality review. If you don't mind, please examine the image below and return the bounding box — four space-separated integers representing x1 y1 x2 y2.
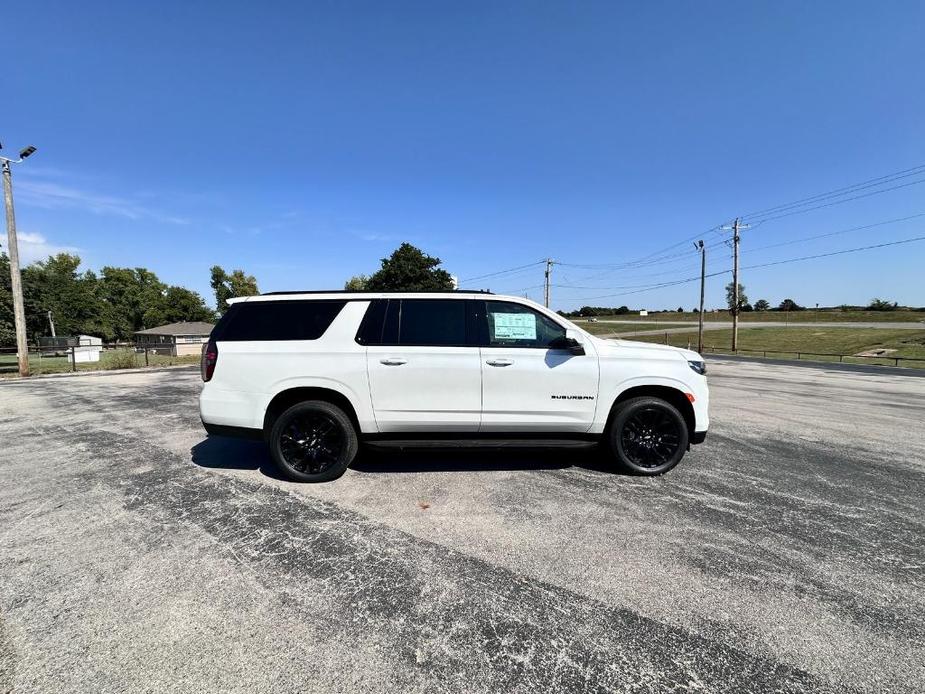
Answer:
366 298 482 433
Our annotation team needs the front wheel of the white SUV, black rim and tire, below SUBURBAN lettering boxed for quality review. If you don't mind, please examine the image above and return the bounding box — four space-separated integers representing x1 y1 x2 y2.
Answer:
607 396 689 476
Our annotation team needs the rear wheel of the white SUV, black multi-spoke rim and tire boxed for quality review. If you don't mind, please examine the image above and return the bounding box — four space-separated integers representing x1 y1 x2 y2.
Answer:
267 400 359 482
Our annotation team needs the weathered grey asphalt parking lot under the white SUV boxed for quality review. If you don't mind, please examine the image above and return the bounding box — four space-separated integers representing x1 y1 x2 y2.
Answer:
0 360 925 694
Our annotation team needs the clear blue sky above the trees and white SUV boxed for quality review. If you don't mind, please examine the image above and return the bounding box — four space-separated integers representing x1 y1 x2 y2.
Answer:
0 0 925 309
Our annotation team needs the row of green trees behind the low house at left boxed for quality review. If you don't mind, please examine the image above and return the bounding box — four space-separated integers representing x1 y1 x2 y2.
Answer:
0 252 258 347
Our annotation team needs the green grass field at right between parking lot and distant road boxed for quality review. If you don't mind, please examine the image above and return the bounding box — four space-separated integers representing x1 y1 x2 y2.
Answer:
638 327 925 368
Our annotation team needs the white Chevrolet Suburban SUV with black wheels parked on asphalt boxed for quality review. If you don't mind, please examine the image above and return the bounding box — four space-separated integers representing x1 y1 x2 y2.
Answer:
199 292 709 482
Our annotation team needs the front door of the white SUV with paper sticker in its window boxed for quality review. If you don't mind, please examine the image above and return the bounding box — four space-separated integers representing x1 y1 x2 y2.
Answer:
475 300 599 433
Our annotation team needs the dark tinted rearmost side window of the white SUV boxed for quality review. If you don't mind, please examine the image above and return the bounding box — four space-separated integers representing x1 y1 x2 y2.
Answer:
213 301 347 342
